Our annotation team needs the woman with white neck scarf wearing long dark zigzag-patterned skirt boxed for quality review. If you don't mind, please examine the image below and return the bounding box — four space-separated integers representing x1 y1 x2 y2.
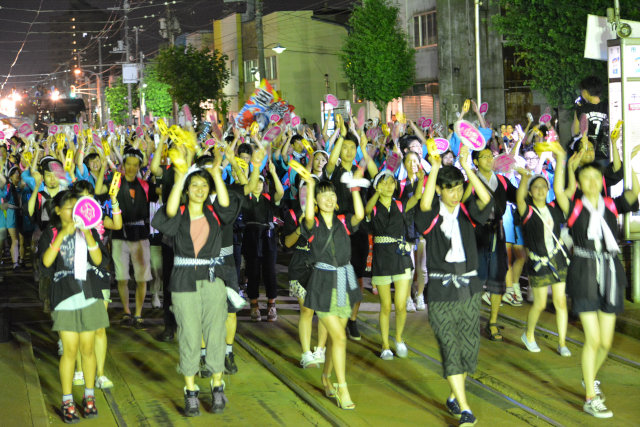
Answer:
415 146 493 426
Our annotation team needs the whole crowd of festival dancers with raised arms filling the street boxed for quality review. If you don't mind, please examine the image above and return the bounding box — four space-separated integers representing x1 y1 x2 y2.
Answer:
0 78 640 426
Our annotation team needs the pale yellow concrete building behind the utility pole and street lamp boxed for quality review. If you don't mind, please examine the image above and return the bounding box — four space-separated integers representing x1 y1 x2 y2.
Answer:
213 11 352 123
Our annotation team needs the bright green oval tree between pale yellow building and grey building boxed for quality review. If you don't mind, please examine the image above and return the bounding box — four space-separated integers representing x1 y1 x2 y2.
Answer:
341 0 415 111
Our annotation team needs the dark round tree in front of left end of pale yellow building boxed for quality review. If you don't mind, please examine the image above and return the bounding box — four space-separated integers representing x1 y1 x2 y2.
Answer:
157 46 229 118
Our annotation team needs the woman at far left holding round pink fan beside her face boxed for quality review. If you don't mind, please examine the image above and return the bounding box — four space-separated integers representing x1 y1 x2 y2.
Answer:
38 190 109 423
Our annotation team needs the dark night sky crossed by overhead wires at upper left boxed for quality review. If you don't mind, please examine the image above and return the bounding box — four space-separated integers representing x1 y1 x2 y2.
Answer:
0 0 351 95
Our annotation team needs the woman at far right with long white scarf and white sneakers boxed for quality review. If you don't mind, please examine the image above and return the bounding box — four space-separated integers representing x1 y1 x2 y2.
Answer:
553 144 640 418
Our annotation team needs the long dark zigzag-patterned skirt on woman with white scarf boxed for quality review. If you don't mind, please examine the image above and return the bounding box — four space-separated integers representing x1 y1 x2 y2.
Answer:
429 293 480 378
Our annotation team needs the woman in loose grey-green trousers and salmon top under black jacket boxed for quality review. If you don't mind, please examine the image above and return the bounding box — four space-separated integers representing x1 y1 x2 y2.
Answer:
152 149 234 417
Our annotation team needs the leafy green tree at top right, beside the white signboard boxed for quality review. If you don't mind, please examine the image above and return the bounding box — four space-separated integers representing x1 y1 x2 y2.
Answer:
493 0 640 106
